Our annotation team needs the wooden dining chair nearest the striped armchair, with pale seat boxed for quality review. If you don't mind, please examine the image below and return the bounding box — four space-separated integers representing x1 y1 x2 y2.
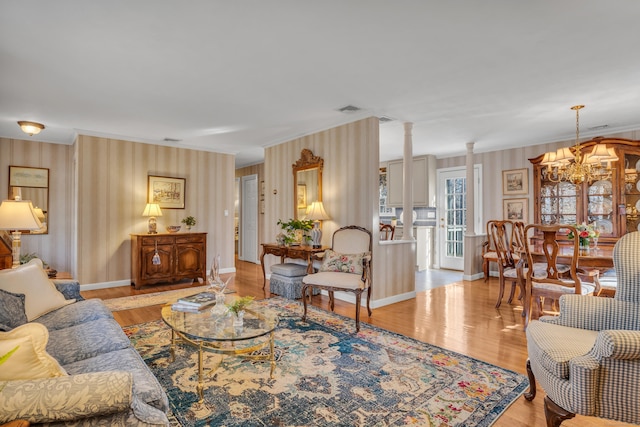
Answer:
524 224 597 327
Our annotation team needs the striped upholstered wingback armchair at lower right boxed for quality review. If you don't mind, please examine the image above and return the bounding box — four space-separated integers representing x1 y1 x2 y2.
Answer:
525 231 640 426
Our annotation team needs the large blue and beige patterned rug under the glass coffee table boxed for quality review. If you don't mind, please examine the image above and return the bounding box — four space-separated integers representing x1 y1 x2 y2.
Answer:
124 298 528 427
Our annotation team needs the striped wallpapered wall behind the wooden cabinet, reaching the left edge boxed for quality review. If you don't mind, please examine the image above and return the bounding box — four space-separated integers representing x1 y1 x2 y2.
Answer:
0 136 235 285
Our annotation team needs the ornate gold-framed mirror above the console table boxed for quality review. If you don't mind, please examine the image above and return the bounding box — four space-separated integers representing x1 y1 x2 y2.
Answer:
293 148 324 219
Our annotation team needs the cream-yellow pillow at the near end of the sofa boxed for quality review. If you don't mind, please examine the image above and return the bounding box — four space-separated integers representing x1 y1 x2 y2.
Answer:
0 323 67 381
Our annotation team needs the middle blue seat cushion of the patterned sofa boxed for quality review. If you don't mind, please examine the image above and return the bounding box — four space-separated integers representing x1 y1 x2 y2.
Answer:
47 319 131 365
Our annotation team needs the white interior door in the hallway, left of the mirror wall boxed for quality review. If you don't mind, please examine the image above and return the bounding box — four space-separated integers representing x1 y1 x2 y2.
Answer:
238 175 258 264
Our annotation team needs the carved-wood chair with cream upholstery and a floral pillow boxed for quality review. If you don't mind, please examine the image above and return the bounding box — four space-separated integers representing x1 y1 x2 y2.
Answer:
302 225 372 331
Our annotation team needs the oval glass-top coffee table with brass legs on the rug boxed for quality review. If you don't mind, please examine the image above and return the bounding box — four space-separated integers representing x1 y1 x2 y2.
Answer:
162 295 278 402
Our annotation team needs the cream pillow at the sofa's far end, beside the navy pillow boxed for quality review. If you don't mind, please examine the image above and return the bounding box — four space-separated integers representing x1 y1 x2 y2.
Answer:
0 258 75 322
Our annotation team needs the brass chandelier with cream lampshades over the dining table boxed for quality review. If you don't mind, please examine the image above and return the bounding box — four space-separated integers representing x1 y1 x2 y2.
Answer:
540 105 618 185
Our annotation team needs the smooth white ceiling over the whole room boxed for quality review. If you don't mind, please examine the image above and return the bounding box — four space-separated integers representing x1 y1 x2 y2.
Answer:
0 0 640 167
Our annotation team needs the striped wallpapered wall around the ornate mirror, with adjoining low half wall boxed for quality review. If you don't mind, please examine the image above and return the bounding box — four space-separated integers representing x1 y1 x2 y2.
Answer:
260 118 415 300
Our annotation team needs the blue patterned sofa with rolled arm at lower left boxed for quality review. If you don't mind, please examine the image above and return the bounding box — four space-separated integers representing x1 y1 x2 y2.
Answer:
0 265 169 426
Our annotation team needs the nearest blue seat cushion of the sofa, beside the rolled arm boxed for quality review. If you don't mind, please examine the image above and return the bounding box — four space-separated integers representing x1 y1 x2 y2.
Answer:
64 347 169 412
